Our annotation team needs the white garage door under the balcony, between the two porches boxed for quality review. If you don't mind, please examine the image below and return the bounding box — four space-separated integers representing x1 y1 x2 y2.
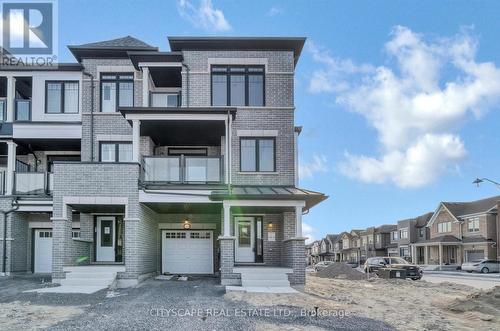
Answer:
162 230 213 274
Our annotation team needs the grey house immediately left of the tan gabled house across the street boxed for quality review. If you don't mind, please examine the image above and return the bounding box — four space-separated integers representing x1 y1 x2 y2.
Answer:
391 212 433 264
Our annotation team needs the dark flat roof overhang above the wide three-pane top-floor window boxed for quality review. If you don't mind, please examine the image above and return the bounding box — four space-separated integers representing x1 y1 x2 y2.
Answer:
168 37 306 64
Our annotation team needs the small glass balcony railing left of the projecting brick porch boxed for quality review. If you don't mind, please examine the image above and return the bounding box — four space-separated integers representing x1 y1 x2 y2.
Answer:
14 171 54 195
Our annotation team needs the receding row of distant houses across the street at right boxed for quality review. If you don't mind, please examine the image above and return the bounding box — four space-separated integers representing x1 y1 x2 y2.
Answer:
306 196 500 267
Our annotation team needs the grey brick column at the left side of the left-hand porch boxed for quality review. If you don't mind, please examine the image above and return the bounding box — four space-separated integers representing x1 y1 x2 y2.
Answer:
52 206 72 283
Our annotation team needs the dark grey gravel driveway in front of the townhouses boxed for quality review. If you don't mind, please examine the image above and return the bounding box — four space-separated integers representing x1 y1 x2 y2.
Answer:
0 278 392 330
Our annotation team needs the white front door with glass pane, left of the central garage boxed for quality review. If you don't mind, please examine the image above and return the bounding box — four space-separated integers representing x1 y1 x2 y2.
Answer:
96 216 116 262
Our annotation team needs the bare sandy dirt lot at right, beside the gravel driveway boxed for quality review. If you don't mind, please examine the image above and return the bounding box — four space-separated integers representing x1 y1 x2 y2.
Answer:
226 275 500 330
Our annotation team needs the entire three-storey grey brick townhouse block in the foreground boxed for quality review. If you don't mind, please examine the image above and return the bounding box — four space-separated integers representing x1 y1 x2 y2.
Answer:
0 36 327 286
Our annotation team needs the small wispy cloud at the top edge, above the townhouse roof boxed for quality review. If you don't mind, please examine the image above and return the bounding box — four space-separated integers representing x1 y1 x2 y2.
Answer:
177 0 231 31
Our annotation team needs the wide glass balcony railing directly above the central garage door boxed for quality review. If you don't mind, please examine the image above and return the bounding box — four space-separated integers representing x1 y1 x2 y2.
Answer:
142 156 223 184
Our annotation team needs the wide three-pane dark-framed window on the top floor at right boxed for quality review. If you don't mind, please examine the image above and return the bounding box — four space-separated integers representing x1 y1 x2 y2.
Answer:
210 65 266 107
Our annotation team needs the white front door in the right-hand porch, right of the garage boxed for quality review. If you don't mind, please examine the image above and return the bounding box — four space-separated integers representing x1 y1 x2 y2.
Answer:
234 217 255 262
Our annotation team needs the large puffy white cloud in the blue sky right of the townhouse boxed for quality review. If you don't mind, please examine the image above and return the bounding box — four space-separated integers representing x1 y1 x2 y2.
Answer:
311 26 500 187
